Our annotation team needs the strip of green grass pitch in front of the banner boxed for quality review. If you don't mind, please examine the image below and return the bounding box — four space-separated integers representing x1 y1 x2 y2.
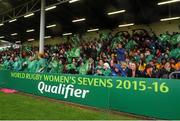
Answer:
0 92 140 120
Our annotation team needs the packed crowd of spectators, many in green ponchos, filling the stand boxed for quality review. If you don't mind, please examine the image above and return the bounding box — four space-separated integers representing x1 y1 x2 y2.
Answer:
0 32 180 78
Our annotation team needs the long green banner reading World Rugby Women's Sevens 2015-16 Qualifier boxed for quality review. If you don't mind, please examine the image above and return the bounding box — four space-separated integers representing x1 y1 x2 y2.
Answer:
0 71 180 120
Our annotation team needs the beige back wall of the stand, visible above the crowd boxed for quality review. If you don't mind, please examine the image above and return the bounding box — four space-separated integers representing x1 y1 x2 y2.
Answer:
24 20 180 46
